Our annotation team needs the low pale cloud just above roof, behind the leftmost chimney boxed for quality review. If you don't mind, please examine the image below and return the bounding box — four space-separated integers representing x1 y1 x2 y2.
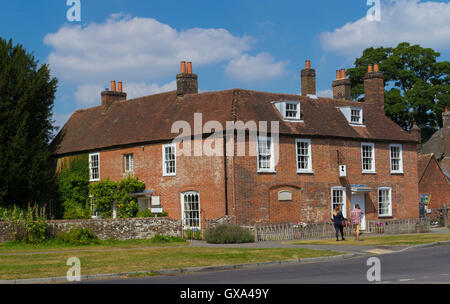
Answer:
74 80 177 106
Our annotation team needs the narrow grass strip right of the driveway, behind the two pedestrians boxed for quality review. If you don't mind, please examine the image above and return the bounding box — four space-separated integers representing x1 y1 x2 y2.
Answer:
289 233 450 246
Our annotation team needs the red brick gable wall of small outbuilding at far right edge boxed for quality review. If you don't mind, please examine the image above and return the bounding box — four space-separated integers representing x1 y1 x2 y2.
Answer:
419 157 450 209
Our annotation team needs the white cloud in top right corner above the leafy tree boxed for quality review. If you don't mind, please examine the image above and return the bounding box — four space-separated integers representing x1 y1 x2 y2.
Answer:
320 0 450 57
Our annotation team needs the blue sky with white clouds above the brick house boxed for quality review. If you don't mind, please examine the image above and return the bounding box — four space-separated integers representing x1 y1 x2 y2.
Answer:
0 0 450 131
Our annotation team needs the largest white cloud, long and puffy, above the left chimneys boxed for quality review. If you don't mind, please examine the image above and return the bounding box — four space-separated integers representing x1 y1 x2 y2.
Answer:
44 14 252 83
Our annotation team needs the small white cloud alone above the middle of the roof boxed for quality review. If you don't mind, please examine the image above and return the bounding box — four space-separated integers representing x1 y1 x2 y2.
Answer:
225 53 287 81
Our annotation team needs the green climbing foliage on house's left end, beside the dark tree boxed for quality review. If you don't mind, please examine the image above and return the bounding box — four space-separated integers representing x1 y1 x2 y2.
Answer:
56 155 90 219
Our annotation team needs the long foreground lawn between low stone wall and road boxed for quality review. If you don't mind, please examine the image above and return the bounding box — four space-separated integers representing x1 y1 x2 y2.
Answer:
0 246 341 280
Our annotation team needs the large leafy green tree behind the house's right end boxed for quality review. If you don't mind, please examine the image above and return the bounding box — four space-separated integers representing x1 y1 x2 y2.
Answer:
347 42 450 141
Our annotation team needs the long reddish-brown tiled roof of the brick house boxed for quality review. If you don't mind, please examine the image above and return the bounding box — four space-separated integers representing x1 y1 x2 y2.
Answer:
52 89 416 155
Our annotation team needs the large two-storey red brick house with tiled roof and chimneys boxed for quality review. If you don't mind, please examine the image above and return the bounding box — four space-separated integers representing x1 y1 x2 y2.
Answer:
53 61 419 228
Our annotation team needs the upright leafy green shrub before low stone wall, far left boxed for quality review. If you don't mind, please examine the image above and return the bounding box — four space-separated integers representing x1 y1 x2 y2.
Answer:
23 204 49 244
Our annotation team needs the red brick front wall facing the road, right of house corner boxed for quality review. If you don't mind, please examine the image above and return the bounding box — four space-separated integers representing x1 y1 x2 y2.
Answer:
234 137 419 224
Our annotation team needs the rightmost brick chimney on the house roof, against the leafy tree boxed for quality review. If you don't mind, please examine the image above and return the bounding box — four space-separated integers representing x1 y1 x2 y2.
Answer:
364 64 384 113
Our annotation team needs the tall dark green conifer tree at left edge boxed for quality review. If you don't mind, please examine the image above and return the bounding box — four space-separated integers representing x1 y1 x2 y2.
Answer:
0 38 57 206
